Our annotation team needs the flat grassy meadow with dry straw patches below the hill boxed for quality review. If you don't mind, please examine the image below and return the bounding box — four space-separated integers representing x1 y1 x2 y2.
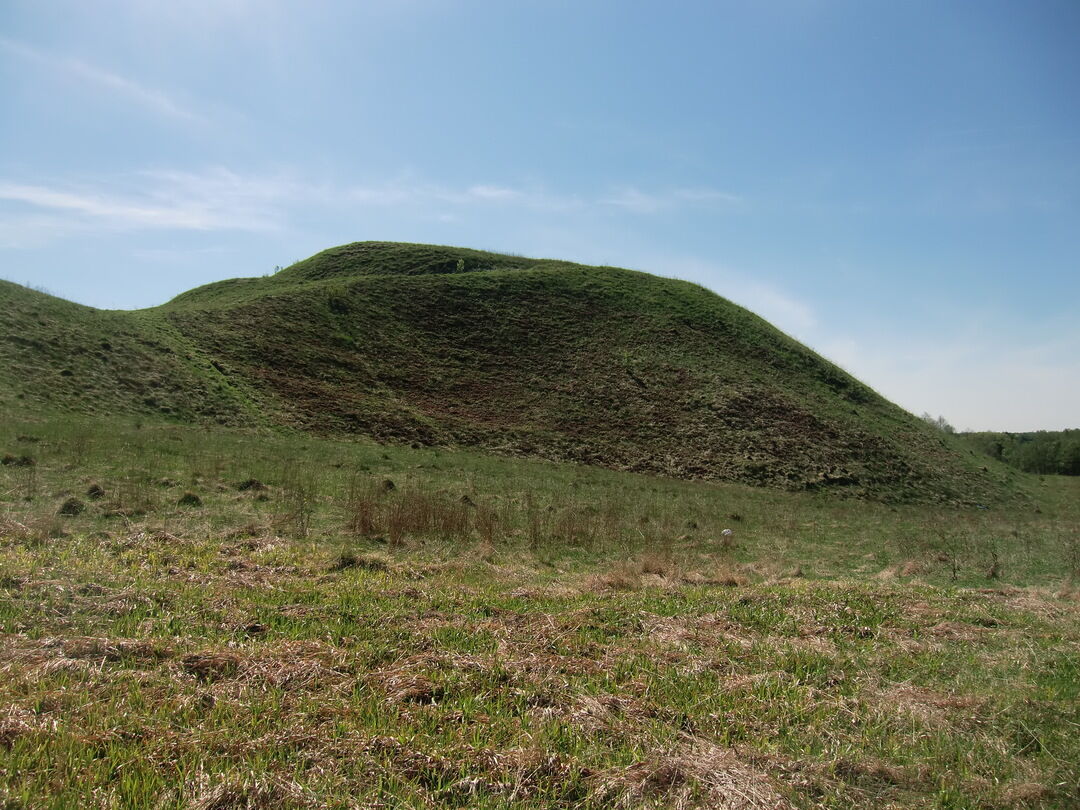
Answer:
0 415 1080 810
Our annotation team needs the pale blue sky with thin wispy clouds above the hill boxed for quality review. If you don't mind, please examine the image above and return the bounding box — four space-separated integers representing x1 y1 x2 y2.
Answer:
0 0 1080 430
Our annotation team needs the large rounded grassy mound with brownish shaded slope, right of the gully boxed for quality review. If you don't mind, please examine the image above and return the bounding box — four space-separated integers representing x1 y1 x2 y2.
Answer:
3 243 1003 501
